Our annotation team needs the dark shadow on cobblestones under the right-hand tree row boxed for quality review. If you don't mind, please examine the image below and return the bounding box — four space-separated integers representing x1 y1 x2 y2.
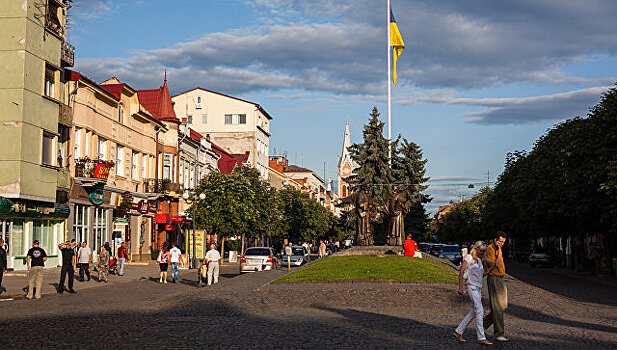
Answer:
506 262 617 305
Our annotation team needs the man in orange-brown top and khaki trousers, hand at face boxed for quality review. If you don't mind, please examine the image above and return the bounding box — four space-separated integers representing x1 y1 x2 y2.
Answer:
484 231 508 342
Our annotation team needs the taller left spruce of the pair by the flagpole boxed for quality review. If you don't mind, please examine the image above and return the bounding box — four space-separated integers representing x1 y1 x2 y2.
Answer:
349 106 394 203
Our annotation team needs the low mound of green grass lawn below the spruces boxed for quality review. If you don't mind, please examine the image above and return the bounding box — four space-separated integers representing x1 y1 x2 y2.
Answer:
275 255 458 282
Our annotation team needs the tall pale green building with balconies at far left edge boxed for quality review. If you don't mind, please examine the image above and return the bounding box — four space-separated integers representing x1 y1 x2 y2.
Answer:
0 0 74 270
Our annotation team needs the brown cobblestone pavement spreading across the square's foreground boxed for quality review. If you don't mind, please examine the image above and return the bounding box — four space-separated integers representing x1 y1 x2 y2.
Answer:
0 266 617 349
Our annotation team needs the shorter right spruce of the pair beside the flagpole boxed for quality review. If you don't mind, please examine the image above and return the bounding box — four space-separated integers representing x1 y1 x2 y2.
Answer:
392 135 431 235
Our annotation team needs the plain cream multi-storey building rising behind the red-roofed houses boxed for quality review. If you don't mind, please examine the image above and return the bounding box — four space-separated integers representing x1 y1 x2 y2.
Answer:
172 88 272 179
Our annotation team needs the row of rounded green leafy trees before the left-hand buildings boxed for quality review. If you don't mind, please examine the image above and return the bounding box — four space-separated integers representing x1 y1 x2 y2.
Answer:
190 167 340 252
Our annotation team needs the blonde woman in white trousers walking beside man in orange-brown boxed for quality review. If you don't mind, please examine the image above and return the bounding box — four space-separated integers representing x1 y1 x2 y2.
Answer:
454 241 492 345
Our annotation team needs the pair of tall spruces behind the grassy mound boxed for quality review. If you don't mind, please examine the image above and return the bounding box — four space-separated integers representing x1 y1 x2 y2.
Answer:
342 107 431 244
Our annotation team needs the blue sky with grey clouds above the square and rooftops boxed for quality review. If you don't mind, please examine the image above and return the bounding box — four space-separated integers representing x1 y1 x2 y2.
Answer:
68 0 617 212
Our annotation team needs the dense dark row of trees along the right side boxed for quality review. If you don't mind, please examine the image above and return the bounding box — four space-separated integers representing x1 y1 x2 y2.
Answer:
439 88 617 262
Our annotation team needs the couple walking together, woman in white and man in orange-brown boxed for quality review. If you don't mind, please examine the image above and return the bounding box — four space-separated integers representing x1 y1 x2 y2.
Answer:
454 231 508 345
